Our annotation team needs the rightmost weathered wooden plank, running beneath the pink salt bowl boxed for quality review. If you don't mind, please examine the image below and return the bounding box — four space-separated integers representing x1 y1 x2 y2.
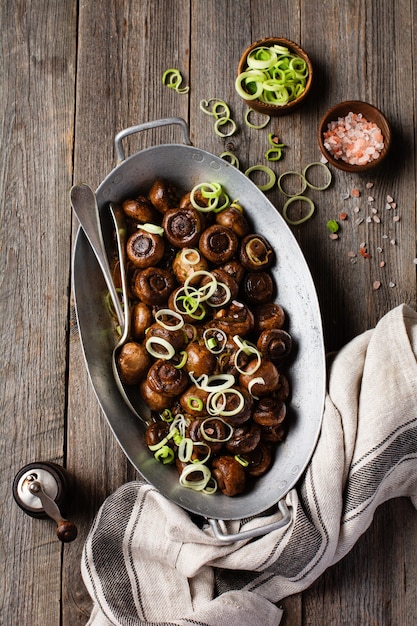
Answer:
301 2 416 625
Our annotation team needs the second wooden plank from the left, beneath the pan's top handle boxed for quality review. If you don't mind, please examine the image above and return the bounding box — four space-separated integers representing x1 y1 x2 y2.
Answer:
63 0 190 626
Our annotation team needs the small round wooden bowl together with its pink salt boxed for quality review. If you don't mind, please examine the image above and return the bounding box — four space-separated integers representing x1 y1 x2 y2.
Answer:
318 100 391 172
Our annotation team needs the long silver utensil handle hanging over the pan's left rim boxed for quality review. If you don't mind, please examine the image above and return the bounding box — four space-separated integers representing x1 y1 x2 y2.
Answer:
70 183 125 330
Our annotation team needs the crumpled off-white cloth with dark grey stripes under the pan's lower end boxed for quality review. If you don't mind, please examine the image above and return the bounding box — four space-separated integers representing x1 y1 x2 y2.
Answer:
82 305 417 626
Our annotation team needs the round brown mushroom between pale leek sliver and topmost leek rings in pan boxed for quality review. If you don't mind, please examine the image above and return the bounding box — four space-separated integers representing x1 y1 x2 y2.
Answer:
162 207 202 248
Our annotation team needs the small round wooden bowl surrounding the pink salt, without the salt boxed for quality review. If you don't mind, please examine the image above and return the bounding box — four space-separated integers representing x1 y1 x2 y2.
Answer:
318 100 391 172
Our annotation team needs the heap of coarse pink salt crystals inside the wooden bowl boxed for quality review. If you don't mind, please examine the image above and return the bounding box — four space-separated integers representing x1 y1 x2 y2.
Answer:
323 112 384 165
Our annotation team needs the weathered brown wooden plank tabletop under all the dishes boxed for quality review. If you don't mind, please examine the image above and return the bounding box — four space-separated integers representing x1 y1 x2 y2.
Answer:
0 0 417 626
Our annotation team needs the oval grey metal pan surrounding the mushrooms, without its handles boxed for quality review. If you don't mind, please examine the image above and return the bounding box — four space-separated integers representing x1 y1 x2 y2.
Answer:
73 139 326 520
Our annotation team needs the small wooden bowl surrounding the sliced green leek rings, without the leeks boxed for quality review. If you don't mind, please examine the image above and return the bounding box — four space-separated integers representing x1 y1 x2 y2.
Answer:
237 37 313 116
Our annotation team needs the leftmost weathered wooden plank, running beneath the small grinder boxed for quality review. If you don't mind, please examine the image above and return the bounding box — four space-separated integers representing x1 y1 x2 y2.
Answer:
0 0 76 626
